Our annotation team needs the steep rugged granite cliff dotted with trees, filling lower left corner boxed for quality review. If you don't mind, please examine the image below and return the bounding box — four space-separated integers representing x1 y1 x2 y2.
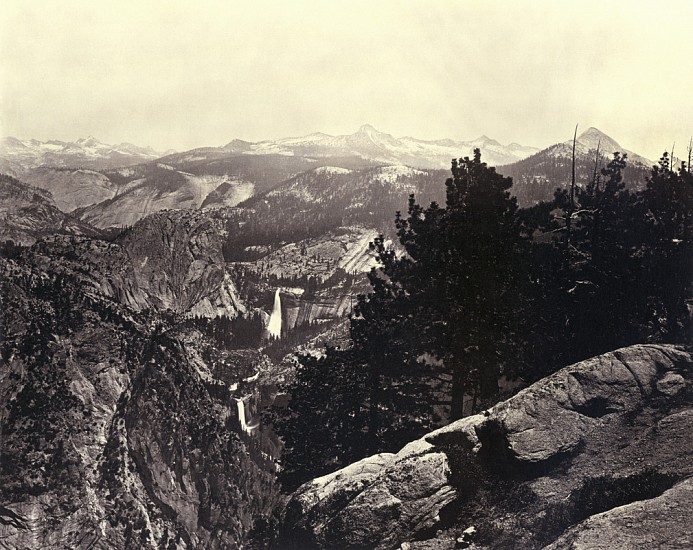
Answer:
0 252 276 549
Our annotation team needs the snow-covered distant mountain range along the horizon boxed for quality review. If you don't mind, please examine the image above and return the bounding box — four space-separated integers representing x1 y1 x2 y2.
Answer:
0 124 538 177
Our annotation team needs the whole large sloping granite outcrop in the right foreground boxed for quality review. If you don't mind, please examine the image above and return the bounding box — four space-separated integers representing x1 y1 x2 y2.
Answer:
279 345 693 550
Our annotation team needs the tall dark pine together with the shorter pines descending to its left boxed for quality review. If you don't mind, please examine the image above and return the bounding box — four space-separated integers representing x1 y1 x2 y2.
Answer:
273 150 529 487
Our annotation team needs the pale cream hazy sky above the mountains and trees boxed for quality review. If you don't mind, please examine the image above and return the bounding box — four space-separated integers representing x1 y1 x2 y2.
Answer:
0 0 693 158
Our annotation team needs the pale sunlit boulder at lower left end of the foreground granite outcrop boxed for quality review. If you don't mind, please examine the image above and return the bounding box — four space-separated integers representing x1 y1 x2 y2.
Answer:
287 452 455 548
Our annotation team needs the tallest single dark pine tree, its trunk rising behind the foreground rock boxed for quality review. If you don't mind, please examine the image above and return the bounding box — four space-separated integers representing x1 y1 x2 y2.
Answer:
397 149 529 419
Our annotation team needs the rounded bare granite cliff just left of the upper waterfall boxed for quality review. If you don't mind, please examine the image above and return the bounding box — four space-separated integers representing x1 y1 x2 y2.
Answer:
25 208 245 317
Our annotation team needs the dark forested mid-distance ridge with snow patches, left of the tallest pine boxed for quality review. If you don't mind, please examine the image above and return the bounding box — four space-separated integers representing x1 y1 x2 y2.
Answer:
225 166 446 261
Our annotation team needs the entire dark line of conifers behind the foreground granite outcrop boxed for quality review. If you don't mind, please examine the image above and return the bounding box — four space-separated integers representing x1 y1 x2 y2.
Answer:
269 150 693 490
